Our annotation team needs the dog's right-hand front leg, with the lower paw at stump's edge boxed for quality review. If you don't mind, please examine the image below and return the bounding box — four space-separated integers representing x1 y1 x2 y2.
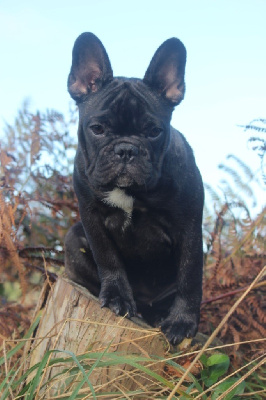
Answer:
161 221 203 344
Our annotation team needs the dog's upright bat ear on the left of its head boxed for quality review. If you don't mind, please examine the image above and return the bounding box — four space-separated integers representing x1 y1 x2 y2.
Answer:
67 32 113 103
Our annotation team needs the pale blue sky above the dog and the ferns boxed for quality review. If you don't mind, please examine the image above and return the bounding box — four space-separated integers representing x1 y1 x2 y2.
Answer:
0 0 266 205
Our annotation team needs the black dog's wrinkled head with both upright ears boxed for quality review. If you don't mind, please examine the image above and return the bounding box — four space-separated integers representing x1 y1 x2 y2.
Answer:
68 33 186 191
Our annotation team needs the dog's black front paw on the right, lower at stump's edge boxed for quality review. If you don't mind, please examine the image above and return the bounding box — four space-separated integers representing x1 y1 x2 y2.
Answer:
161 314 198 345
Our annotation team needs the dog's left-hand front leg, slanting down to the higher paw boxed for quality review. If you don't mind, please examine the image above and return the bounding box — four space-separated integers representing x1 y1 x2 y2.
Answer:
80 207 136 317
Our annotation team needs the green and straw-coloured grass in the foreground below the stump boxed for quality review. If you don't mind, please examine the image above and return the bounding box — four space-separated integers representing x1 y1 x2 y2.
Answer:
0 267 266 400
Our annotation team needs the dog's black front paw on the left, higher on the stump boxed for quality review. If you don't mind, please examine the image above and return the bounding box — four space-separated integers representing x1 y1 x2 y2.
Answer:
99 282 137 318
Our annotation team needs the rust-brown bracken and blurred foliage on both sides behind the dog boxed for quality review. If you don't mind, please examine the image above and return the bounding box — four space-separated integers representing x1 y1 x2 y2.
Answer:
0 103 266 399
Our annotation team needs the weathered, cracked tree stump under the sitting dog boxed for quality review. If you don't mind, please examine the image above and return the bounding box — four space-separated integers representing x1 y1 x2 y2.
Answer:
24 278 168 399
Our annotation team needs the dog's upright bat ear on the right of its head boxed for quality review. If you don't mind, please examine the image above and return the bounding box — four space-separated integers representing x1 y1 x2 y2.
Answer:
143 38 186 106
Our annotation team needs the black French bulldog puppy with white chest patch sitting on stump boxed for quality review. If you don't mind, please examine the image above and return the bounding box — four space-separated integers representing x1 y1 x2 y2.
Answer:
65 33 204 344
